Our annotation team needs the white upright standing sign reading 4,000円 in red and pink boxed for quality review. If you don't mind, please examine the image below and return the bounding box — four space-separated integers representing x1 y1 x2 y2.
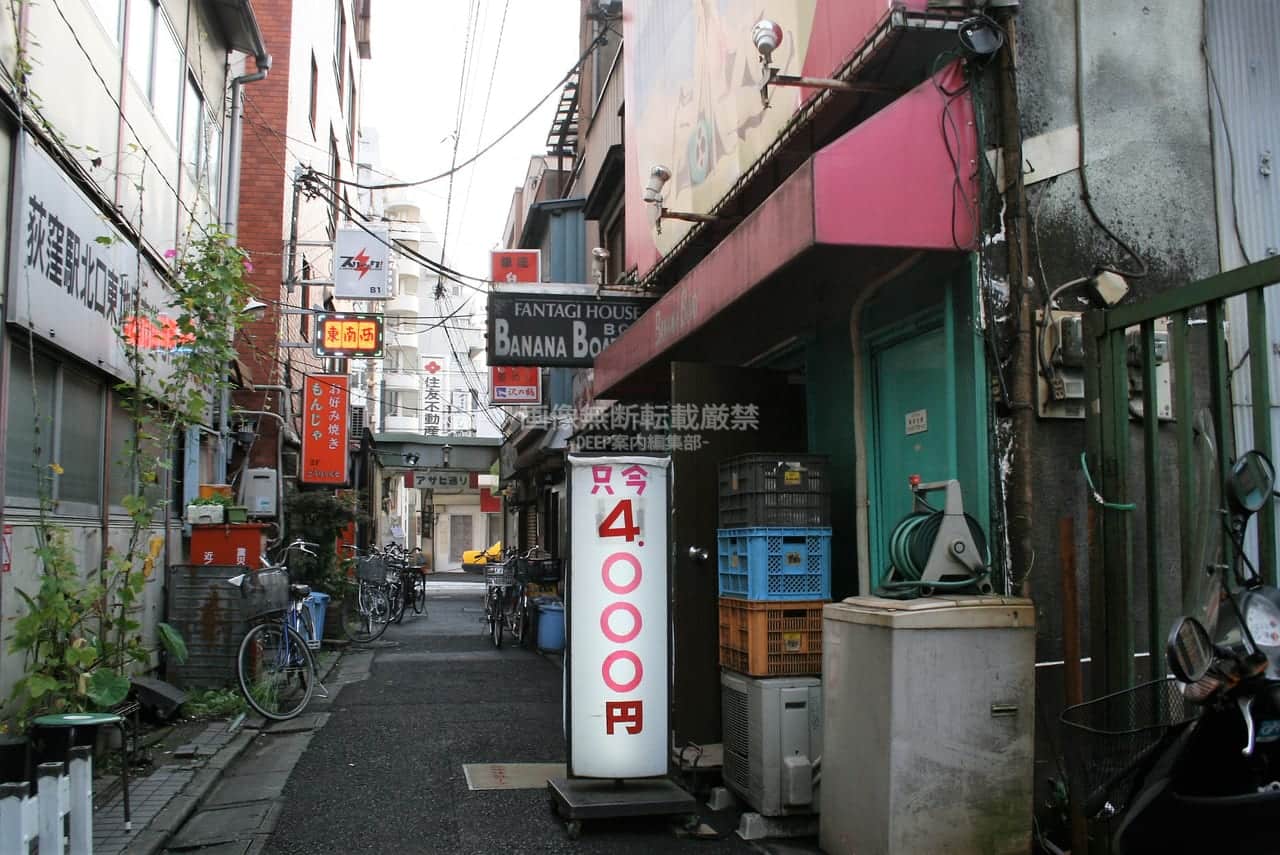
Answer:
567 456 671 778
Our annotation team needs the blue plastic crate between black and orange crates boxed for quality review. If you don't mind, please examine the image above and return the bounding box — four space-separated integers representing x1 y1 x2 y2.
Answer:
716 527 831 600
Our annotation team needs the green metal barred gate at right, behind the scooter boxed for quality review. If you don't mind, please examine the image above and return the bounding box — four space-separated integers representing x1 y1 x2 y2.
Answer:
1084 257 1280 696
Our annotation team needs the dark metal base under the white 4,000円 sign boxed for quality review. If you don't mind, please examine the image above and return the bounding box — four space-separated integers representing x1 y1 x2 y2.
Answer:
547 778 699 840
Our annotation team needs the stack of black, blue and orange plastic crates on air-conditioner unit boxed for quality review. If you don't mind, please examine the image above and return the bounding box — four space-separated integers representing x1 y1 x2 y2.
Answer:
717 454 831 677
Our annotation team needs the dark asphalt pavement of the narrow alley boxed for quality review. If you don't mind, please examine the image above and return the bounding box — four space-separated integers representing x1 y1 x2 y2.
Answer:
254 577 760 855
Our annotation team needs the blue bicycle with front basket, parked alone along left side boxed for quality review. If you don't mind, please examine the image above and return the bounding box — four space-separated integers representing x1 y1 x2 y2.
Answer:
227 540 328 722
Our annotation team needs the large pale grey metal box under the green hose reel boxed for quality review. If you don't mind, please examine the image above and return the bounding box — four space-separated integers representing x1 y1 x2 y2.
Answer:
818 596 1036 855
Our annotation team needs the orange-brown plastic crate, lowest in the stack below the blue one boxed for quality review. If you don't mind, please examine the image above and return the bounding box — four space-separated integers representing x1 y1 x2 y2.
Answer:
719 596 827 677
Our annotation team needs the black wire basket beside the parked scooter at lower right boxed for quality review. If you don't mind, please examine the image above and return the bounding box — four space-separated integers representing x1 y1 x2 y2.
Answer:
1060 677 1201 817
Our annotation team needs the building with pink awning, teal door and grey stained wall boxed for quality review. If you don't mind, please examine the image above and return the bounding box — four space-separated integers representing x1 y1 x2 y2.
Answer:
491 0 1280 845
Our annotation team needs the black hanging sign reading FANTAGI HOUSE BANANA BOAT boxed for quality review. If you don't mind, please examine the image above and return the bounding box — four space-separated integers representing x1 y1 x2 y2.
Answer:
488 285 653 367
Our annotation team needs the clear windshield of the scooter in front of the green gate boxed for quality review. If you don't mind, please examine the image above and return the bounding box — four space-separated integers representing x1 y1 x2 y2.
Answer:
1183 410 1222 639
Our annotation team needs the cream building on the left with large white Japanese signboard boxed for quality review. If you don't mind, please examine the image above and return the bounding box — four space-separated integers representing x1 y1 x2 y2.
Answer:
0 0 271 698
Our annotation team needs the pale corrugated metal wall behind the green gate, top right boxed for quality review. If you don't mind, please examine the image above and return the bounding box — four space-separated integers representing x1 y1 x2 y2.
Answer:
1204 0 1280 545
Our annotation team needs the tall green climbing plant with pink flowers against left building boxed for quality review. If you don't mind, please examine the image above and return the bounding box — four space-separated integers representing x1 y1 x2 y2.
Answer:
10 229 252 721
